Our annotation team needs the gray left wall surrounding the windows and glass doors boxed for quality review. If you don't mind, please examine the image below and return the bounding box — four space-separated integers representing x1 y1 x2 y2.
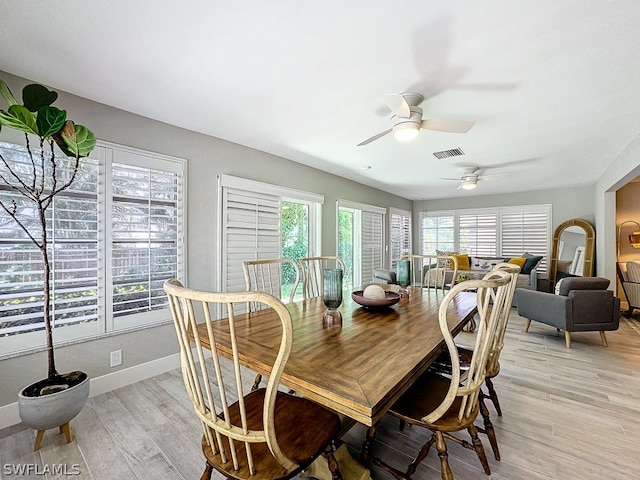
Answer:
0 72 412 406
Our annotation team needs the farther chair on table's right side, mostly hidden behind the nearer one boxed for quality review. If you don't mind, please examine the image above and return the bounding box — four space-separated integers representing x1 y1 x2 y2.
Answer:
429 263 520 460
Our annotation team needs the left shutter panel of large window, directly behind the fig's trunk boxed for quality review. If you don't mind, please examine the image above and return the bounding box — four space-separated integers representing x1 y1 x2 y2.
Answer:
0 144 99 336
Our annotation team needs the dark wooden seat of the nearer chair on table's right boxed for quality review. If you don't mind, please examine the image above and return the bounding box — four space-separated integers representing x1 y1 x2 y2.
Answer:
390 370 478 432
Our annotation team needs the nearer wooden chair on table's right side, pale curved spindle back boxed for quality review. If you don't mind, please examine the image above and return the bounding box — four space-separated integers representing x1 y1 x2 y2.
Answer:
367 272 511 480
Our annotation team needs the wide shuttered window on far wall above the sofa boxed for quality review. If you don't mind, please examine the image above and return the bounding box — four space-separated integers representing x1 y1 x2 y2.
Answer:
420 205 551 273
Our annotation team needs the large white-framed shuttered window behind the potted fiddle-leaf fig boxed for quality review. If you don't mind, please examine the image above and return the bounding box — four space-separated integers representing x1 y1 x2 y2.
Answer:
0 142 185 354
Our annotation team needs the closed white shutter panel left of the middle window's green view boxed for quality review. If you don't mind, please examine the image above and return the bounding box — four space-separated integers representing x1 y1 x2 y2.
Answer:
222 187 280 292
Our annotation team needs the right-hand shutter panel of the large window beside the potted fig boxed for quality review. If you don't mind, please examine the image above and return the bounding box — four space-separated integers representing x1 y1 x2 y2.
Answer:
110 159 184 328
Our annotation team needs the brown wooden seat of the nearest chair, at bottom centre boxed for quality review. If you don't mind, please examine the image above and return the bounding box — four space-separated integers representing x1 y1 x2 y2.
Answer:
202 388 341 480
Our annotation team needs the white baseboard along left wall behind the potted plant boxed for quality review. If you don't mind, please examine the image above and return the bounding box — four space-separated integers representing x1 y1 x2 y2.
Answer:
0 353 180 430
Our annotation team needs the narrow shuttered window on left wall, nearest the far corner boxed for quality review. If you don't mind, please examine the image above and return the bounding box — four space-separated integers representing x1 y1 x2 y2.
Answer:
338 200 386 288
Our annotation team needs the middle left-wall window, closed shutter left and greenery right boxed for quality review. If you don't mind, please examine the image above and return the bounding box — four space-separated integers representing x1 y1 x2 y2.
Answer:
218 175 324 299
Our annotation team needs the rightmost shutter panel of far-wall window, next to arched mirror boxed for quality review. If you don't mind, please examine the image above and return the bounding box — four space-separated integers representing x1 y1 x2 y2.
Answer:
501 208 550 273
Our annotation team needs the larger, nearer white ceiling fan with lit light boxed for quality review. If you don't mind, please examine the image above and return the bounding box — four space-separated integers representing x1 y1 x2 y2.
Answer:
357 92 474 147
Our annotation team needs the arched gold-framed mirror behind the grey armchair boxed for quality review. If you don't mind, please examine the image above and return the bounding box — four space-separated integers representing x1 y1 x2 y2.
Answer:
549 218 596 292
